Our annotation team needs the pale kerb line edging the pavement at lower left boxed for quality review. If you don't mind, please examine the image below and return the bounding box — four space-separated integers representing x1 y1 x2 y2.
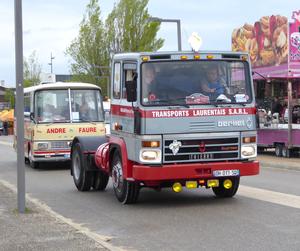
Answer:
0 179 125 251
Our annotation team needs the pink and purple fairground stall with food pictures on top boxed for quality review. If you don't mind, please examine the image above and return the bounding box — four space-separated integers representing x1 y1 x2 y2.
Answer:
232 11 300 157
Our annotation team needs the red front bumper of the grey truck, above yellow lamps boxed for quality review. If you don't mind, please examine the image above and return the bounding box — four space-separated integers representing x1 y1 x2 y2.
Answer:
132 161 259 181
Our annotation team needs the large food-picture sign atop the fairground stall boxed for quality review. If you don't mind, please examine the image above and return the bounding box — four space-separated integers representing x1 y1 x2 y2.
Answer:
232 15 288 68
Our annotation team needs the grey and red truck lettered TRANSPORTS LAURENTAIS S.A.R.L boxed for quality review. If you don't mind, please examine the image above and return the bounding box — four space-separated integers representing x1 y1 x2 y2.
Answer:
71 52 259 204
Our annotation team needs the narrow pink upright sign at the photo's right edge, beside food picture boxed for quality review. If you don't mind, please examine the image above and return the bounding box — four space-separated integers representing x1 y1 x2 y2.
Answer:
289 11 300 63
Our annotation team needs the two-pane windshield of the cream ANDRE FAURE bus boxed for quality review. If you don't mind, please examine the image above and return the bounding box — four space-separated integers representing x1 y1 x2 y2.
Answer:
35 89 103 123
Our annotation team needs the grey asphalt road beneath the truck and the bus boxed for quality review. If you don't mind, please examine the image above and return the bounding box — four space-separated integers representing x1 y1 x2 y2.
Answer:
0 141 300 250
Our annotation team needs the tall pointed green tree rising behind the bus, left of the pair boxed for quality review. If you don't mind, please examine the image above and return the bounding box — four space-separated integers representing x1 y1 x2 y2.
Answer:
66 0 109 93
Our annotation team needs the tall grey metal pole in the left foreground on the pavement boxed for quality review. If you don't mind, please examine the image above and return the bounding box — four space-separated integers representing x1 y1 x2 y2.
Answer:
15 0 25 213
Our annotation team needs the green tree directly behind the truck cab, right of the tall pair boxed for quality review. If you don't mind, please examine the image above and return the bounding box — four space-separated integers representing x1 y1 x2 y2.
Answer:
106 0 164 52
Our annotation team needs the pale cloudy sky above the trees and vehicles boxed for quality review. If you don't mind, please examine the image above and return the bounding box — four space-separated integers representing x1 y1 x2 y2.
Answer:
0 0 300 87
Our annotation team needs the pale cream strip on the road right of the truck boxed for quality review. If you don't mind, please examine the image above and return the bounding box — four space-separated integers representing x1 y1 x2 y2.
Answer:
238 185 300 209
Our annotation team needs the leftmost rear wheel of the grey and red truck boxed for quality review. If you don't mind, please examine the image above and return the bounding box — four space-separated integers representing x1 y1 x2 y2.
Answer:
71 143 92 191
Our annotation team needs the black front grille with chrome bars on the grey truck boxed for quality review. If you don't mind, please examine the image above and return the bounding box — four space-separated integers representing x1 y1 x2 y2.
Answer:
163 137 240 163
